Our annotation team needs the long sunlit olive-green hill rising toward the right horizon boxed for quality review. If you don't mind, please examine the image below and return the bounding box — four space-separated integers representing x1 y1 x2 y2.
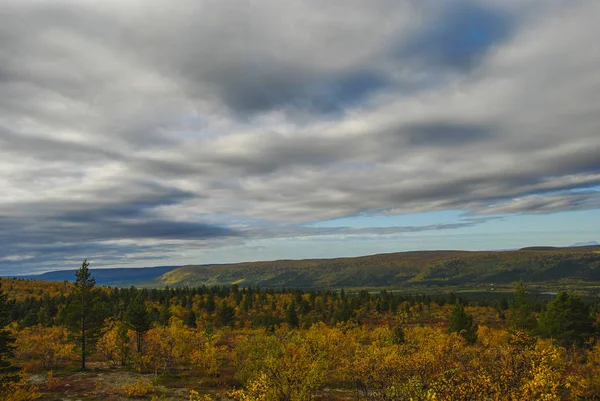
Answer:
157 246 600 288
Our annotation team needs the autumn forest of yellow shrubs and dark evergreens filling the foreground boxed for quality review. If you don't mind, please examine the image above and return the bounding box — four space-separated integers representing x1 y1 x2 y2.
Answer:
0 262 600 401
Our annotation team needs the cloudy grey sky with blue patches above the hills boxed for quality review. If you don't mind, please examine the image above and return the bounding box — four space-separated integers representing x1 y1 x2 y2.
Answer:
0 0 600 275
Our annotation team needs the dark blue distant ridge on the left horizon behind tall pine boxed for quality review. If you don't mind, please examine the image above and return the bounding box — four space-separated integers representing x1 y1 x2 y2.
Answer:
15 266 180 287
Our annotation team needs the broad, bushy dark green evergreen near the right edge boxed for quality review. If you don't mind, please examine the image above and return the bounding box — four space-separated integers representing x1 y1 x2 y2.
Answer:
539 291 596 346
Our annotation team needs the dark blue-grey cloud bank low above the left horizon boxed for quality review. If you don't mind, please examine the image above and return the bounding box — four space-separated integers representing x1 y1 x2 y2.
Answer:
0 182 236 243
